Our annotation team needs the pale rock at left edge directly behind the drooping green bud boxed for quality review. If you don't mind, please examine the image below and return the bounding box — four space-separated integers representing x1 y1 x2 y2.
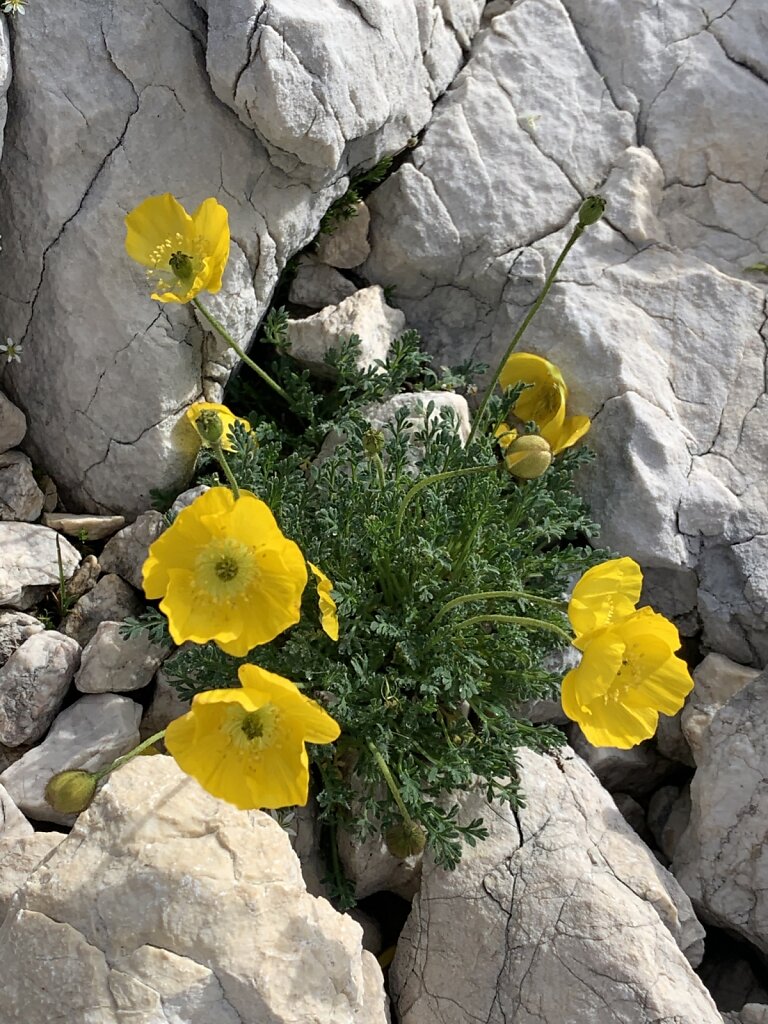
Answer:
0 693 141 825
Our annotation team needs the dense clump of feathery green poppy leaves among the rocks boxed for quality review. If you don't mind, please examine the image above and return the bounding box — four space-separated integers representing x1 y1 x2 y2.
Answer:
151 327 601 872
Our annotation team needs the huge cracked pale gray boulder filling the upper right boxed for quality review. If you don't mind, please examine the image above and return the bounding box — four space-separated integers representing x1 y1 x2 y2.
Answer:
364 0 768 665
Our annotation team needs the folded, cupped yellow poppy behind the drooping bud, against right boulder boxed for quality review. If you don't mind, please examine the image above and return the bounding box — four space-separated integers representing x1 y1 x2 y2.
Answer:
499 352 590 455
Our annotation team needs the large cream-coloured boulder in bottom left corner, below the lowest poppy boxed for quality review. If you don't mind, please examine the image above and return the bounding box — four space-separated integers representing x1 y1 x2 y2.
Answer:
0 756 387 1024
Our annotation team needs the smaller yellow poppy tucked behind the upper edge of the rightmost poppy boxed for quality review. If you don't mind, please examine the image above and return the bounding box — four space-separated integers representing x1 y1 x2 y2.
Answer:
568 558 643 650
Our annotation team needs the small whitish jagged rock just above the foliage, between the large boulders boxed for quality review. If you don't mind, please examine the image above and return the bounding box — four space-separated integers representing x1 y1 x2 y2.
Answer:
288 287 406 377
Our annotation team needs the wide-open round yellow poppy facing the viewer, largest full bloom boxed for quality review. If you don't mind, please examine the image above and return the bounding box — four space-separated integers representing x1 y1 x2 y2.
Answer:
143 487 307 657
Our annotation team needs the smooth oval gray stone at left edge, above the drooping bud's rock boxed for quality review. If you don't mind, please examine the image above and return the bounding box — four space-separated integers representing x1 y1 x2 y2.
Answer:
0 630 80 746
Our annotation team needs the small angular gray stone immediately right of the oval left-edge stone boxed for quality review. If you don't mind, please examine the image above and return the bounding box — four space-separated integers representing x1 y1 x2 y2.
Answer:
75 622 171 693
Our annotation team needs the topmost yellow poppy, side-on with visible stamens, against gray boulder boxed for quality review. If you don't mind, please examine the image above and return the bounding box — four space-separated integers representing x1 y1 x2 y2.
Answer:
125 193 229 302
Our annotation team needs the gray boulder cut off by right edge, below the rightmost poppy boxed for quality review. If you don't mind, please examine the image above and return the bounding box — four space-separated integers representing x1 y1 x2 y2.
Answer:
674 672 768 952
